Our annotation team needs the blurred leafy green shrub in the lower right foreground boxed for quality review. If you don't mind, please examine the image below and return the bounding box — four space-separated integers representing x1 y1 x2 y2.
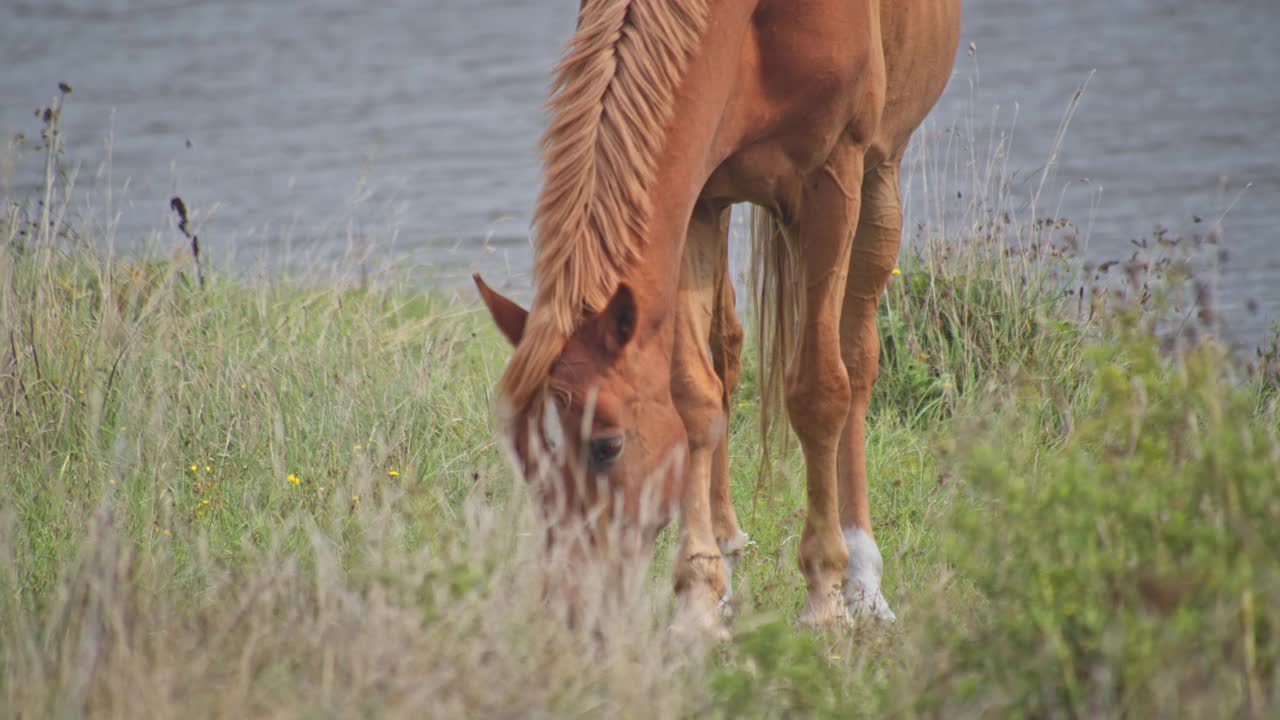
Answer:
905 323 1280 717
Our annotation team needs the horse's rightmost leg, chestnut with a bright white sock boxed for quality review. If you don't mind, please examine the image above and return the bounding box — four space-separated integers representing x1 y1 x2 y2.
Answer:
838 159 902 620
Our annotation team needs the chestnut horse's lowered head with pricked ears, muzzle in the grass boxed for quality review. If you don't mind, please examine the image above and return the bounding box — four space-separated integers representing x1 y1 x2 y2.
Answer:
475 275 686 542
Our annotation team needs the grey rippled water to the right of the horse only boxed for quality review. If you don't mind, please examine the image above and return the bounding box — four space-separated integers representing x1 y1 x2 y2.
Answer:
952 0 1280 342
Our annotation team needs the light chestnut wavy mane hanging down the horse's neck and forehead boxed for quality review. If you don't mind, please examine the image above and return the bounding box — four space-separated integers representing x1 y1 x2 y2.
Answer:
499 0 708 410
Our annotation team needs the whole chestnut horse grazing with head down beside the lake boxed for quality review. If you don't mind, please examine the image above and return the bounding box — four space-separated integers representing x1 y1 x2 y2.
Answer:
476 0 960 628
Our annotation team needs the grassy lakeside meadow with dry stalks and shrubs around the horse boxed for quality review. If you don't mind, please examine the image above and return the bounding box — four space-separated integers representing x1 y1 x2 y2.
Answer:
0 89 1280 717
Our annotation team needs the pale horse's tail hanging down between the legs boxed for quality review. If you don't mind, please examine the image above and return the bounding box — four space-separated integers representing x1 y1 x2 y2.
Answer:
750 206 804 479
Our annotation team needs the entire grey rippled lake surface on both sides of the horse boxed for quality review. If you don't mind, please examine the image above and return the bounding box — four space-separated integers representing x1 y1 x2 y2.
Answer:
0 0 1280 341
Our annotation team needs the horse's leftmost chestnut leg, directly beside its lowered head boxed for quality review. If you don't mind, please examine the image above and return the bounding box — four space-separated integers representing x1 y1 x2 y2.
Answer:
671 198 727 632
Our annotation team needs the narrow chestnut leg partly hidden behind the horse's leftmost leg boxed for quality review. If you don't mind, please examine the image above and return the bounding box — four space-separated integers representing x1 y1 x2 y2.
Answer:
710 213 748 596
